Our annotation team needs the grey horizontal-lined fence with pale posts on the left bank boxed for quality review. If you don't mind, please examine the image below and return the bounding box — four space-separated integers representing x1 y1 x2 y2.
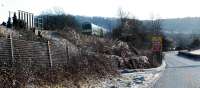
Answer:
0 36 69 68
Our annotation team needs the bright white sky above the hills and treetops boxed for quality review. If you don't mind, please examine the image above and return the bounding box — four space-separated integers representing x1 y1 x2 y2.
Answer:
0 0 200 22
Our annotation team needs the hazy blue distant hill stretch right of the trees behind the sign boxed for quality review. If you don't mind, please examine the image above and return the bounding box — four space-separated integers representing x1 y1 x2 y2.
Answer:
162 17 200 34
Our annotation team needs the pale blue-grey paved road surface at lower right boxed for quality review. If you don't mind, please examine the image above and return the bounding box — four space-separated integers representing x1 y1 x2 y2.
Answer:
153 52 200 88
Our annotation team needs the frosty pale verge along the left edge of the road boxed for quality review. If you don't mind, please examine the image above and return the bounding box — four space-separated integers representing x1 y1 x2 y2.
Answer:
101 60 166 88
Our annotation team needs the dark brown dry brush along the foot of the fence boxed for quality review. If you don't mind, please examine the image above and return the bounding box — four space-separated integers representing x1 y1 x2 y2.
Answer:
0 51 118 88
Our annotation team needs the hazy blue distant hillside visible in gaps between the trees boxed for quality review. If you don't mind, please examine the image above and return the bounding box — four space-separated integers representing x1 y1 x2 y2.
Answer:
76 16 200 34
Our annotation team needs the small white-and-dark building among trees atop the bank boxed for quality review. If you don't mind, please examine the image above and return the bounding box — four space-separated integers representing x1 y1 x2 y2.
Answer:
81 22 107 36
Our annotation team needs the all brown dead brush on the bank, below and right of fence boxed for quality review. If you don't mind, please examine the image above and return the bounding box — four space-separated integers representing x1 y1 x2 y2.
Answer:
0 26 155 88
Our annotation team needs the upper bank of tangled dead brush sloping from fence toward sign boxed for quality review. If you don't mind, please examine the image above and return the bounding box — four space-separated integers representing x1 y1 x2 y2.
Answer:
58 30 152 69
